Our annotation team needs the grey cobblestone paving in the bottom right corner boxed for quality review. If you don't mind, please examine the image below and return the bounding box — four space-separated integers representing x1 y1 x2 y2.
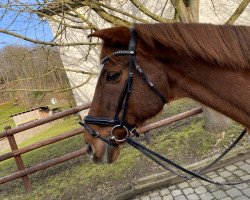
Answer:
137 159 250 200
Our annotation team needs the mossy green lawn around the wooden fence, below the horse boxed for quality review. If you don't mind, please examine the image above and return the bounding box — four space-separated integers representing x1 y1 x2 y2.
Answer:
0 99 246 200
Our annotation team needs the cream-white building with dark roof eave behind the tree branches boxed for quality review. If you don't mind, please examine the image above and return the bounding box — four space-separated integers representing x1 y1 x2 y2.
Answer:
37 0 250 109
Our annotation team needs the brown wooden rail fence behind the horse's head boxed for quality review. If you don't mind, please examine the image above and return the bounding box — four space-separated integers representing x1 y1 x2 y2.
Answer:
0 103 202 192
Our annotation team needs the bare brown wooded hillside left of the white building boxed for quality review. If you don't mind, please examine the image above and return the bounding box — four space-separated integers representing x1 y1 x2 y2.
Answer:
0 45 75 105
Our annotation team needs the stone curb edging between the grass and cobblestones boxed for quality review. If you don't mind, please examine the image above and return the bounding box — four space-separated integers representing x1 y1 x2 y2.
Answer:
108 145 250 200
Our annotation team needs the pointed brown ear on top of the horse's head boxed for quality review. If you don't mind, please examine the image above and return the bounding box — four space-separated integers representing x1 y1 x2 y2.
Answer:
88 26 130 44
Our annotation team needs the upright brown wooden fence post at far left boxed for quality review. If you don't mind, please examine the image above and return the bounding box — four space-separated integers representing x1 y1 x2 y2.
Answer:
4 126 32 192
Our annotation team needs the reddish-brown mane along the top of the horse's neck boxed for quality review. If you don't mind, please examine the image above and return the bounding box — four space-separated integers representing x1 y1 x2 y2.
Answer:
135 23 250 70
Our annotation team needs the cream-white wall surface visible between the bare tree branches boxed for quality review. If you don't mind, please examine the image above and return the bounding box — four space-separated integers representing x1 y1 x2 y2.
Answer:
46 0 250 109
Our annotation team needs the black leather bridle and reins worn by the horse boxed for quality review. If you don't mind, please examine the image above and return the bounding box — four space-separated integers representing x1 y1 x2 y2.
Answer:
79 28 250 186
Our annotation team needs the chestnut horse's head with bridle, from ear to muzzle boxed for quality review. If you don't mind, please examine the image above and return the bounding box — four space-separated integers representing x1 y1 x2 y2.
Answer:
85 27 168 163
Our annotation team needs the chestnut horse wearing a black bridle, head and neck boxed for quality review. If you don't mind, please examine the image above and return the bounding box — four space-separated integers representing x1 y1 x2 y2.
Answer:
85 23 250 163
